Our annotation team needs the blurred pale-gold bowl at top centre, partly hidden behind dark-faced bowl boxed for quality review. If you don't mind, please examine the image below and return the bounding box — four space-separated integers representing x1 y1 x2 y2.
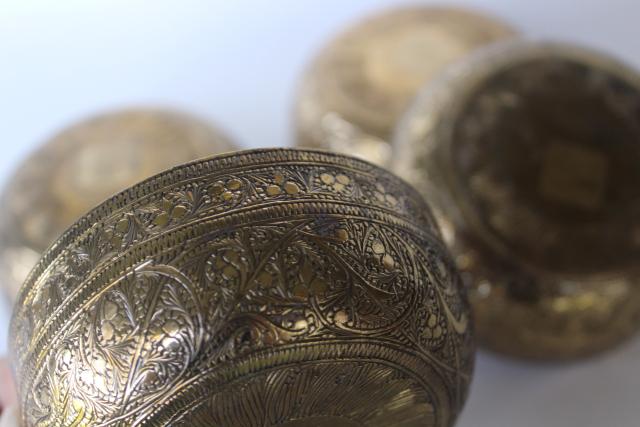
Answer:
295 7 515 165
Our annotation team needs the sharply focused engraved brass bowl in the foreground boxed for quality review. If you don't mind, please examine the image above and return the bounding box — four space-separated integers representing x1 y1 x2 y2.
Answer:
10 149 474 427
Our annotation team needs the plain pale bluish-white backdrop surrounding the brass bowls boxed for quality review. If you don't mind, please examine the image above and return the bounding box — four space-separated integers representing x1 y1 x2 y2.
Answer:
0 0 640 427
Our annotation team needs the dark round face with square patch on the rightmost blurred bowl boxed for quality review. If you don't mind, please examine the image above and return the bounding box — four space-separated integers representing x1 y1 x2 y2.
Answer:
452 57 640 274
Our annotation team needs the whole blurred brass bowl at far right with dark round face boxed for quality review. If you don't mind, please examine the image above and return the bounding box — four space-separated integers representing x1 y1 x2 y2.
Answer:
394 42 640 359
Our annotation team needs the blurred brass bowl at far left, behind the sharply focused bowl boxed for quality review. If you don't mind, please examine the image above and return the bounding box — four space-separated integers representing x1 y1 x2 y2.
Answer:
0 109 233 301
